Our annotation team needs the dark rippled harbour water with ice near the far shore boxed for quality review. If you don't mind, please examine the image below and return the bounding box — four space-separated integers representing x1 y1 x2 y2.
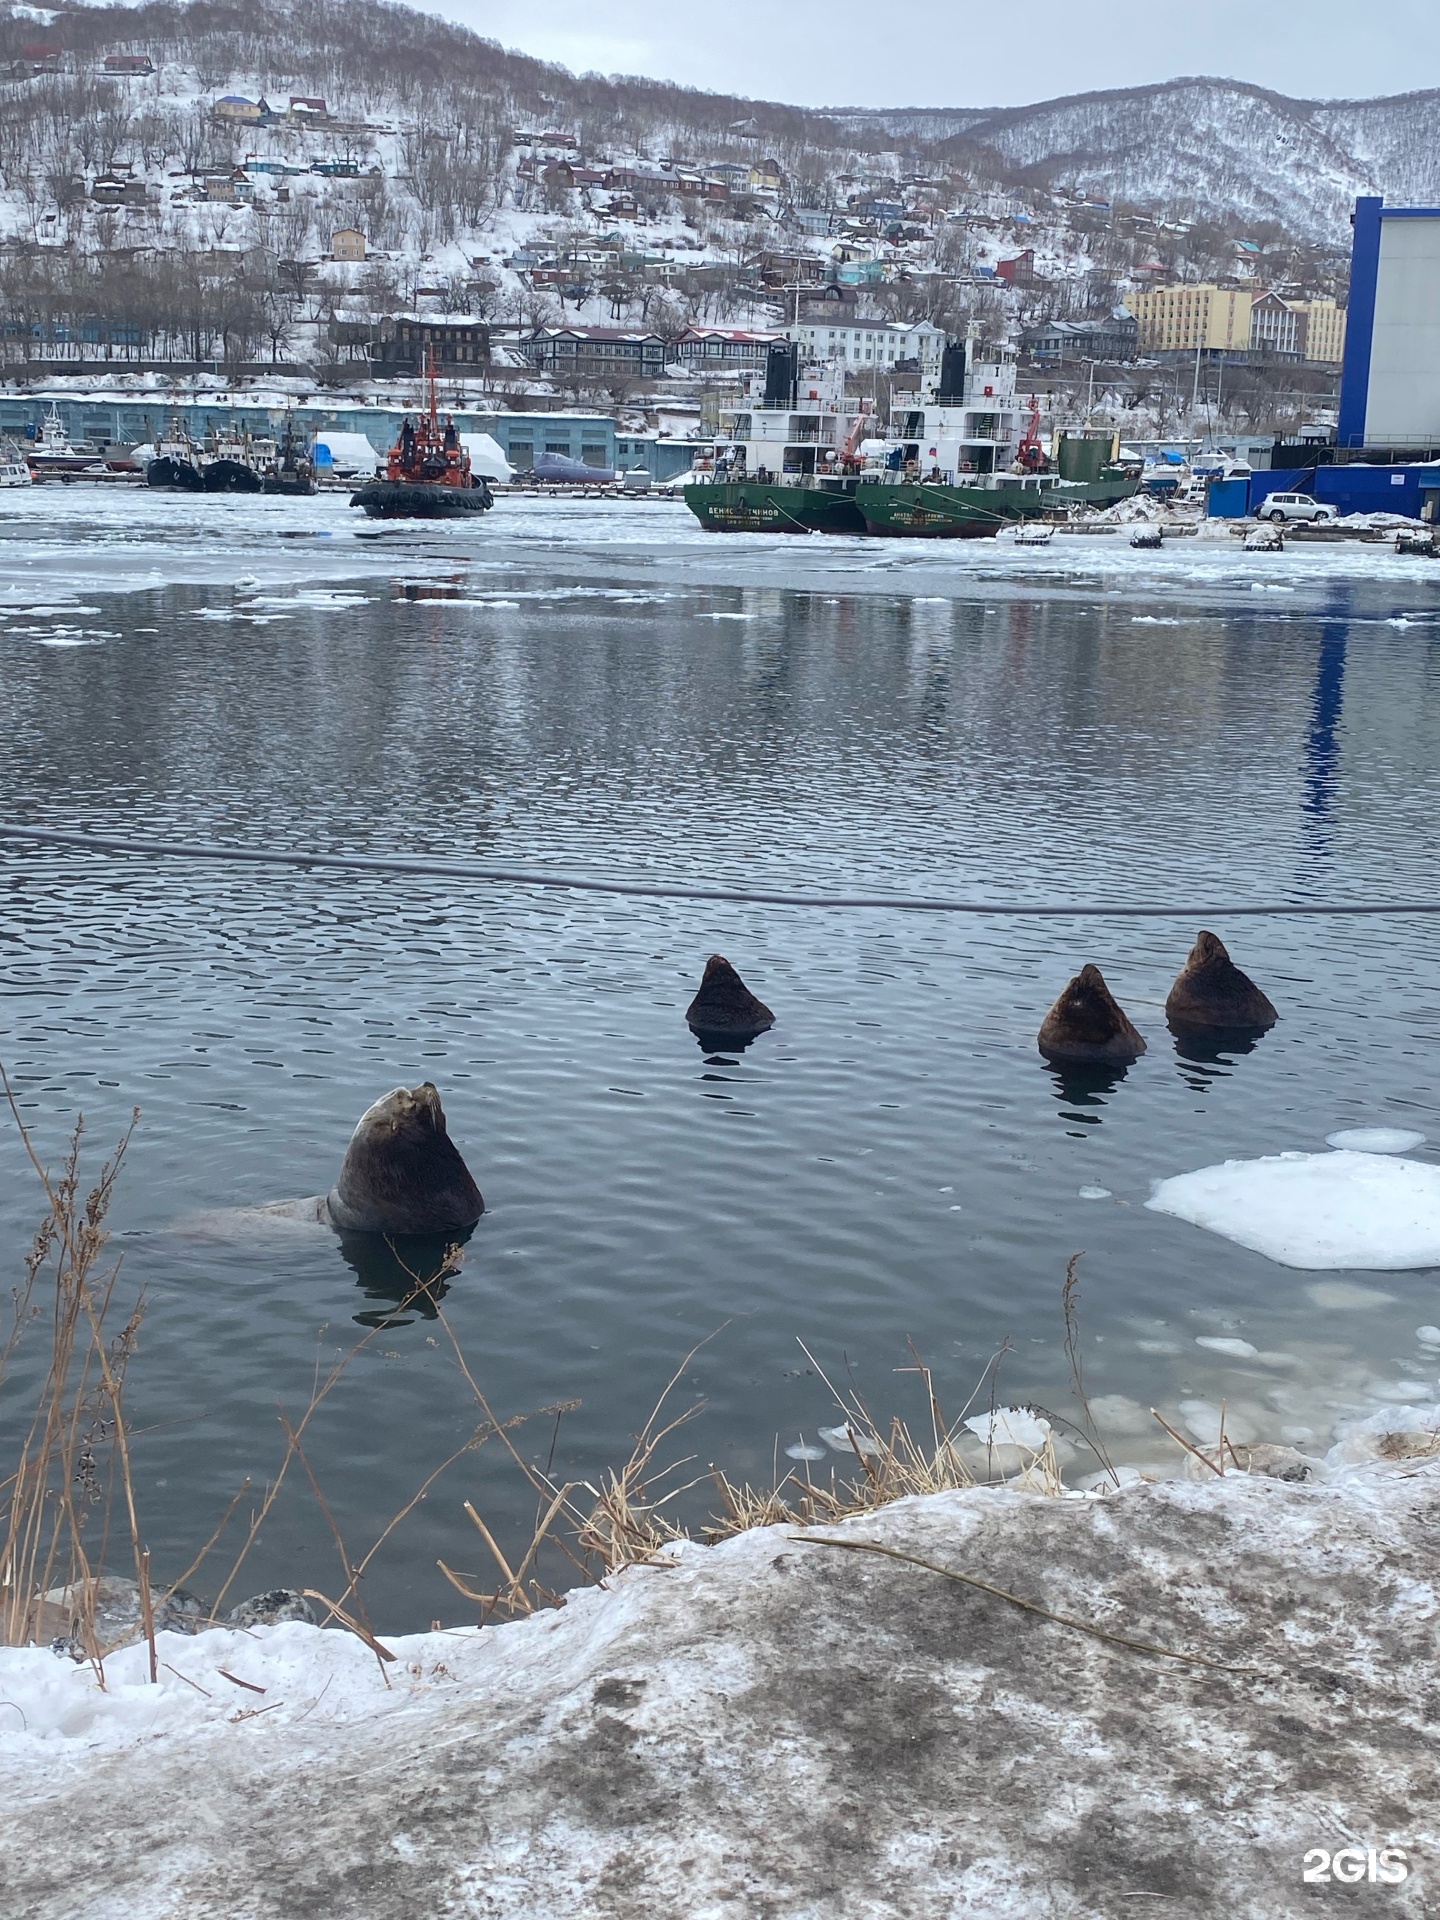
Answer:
0 488 1440 1628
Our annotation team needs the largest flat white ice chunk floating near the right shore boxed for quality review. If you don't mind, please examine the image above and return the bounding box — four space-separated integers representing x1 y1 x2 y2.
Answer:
1146 1152 1440 1267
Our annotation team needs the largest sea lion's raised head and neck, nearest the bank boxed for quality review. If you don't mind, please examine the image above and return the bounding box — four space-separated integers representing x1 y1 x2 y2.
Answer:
324 1081 486 1235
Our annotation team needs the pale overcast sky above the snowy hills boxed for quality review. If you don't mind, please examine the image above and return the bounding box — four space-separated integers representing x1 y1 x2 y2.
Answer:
426 0 1440 108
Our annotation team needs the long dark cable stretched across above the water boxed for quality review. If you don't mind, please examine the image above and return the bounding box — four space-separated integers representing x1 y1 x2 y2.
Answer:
0 826 1440 922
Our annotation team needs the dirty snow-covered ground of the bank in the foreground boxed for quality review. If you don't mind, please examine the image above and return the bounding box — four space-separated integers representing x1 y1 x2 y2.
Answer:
0 1443 1440 1920
